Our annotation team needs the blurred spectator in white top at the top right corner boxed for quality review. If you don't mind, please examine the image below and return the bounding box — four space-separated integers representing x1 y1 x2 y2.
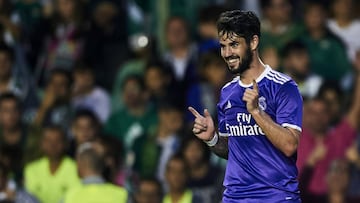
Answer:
327 0 360 61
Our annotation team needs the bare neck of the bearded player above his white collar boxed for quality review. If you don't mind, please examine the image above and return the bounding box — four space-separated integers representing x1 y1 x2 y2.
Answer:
240 52 265 84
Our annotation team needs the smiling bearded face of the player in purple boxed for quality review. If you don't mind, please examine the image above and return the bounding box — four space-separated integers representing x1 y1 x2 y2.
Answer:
219 32 253 74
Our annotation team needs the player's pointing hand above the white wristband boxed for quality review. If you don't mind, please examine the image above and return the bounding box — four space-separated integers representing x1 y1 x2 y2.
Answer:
188 107 215 141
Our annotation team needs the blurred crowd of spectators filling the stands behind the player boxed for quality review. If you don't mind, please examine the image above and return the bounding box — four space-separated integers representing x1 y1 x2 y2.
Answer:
0 0 360 203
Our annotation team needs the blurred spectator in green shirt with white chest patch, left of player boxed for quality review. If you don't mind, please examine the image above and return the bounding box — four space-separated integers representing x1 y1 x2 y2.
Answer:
105 75 157 174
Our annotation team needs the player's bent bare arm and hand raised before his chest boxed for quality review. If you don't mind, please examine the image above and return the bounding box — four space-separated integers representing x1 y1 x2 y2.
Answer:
243 81 300 157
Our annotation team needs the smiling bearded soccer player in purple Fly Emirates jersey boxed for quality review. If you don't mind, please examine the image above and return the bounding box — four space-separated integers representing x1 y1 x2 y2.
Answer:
189 10 302 203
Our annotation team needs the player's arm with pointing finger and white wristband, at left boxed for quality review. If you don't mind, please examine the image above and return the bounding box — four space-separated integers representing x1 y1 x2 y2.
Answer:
189 107 229 159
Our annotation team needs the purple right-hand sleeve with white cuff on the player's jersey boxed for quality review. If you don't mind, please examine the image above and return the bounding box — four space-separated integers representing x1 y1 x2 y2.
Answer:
275 81 303 131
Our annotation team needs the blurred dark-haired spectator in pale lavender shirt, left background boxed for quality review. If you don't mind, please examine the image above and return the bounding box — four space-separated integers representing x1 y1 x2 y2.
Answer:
72 61 111 123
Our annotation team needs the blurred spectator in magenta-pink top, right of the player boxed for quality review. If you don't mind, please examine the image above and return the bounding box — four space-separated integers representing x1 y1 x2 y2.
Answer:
297 72 360 195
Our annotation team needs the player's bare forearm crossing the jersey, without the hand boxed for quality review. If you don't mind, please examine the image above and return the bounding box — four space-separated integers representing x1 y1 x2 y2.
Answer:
251 110 298 157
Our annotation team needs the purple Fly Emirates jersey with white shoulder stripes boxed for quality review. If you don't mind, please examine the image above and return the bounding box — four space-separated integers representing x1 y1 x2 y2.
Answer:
218 66 302 203
